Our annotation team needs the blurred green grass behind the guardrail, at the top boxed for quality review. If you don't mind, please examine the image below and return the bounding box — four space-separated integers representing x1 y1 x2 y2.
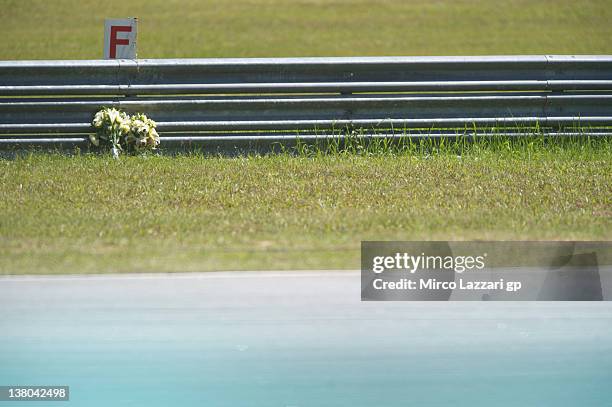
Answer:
0 0 612 59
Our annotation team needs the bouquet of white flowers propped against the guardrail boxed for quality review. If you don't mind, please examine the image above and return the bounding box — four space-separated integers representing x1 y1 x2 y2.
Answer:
89 108 159 158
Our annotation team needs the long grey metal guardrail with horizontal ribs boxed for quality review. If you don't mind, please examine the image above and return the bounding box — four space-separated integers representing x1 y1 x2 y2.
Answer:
0 55 612 145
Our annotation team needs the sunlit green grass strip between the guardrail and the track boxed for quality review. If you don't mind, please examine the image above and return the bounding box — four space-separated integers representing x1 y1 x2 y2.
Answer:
0 140 612 274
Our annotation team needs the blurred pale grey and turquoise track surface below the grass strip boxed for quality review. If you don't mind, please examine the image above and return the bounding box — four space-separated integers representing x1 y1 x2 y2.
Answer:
0 272 612 407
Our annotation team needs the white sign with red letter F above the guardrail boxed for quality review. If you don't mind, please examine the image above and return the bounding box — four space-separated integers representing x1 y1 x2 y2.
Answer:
104 17 138 59
